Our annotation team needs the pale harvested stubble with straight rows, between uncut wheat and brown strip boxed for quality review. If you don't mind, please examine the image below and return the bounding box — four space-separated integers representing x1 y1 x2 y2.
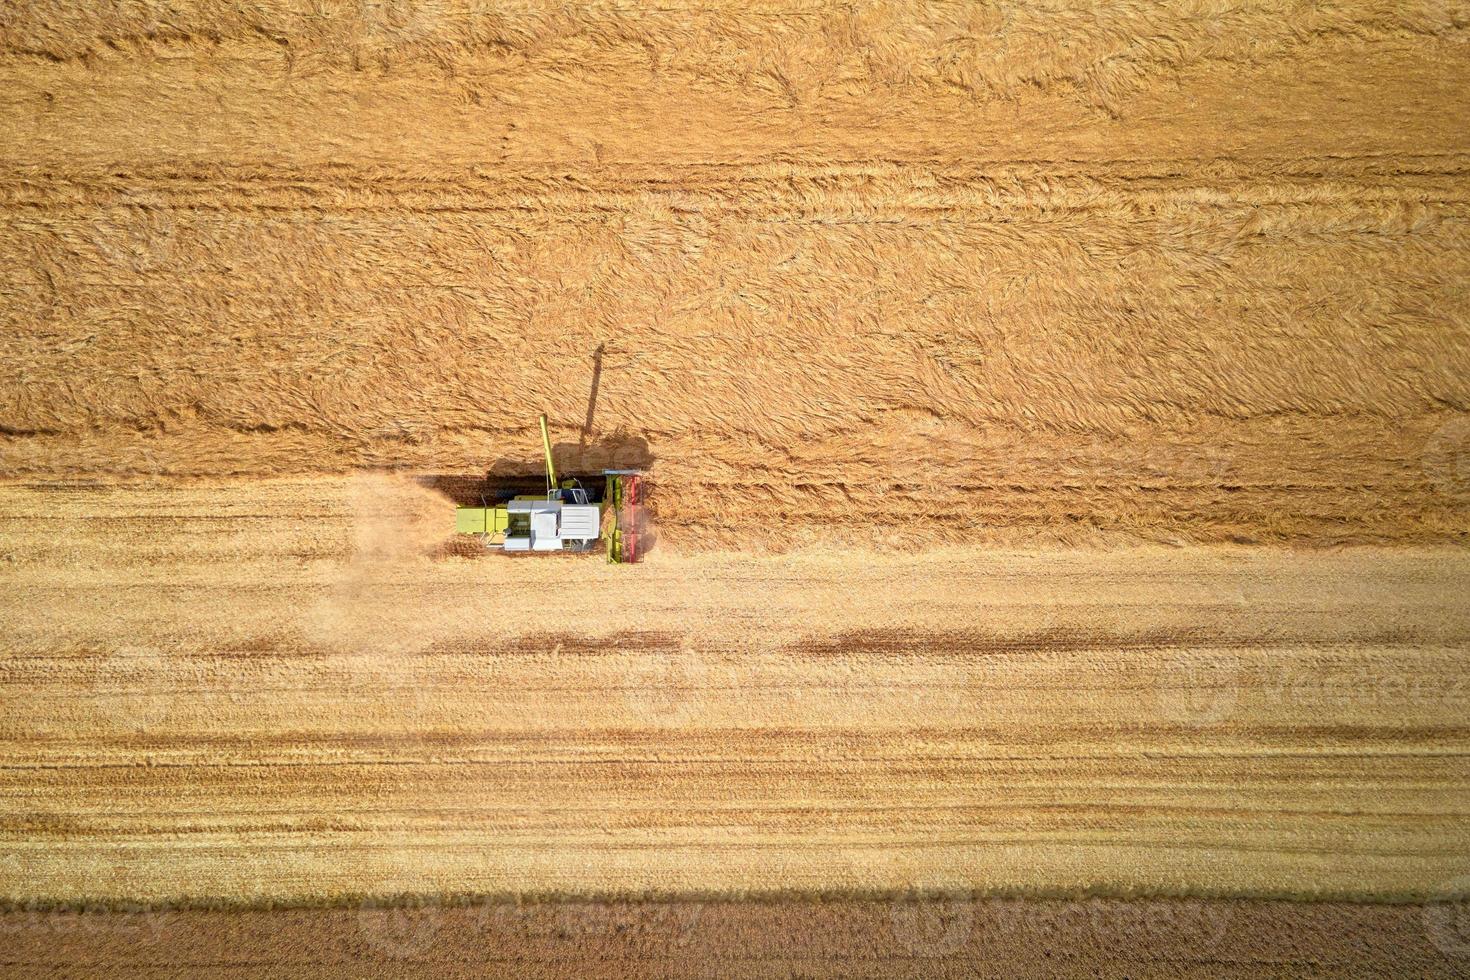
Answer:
0 476 1470 902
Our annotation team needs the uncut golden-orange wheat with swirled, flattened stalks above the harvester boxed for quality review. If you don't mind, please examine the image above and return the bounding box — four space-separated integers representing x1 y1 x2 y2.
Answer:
0 0 1470 548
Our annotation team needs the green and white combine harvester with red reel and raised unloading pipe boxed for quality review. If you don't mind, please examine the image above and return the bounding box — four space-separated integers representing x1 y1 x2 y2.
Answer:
454 414 644 564
